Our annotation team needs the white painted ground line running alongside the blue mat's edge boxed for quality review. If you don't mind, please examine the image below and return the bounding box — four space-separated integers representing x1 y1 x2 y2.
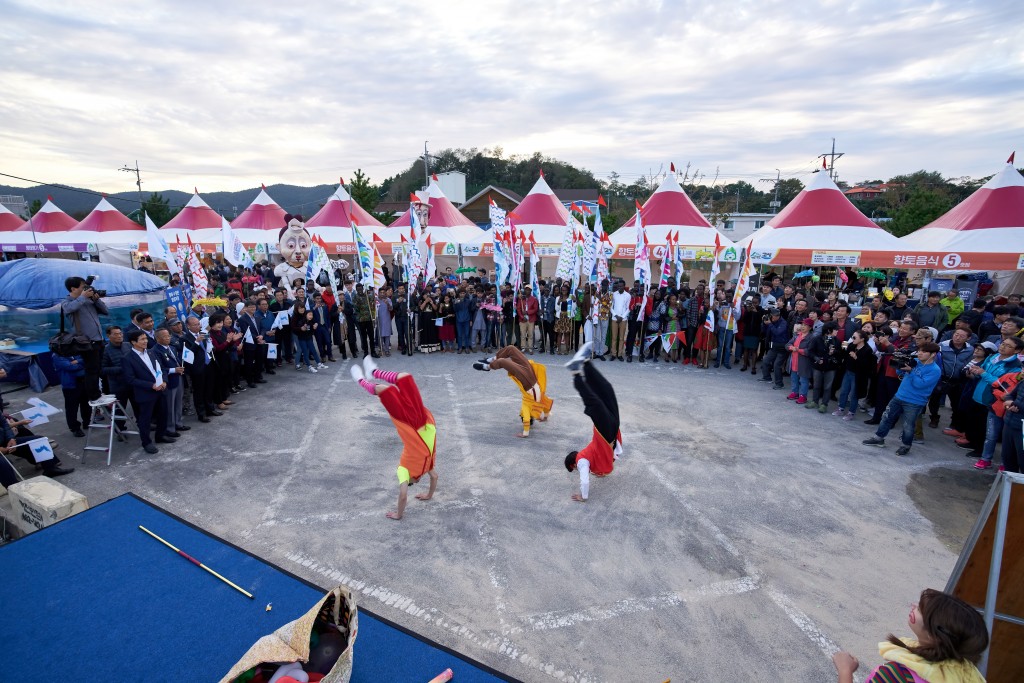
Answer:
285 552 598 683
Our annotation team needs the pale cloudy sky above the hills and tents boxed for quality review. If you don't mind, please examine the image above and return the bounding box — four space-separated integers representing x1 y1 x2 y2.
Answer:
0 0 1024 191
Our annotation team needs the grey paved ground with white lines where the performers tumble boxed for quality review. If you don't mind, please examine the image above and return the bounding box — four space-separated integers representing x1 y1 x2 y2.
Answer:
7 354 993 682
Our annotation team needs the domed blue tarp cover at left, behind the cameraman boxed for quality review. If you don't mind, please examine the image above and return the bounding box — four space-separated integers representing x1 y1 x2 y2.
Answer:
0 258 167 310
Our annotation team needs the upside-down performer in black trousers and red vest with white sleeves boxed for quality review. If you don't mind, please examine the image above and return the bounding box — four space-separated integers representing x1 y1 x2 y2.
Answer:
565 342 623 503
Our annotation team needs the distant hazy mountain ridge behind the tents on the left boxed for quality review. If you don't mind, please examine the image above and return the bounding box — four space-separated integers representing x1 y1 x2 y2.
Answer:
0 185 337 219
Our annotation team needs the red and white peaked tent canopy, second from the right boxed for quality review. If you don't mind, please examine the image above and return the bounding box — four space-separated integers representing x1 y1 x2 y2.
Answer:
737 171 900 266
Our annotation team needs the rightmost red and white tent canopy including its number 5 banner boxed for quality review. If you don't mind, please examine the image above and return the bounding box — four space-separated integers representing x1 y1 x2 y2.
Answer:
897 157 1024 270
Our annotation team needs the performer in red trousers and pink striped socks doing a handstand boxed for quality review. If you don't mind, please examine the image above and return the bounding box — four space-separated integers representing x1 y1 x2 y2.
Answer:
351 355 437 519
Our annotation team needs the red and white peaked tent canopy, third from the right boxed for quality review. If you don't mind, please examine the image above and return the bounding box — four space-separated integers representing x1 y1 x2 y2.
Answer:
608 173 732 258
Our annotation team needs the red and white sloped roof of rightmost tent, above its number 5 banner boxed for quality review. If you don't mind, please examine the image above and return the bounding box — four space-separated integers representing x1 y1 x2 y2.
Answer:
922 164 1024 232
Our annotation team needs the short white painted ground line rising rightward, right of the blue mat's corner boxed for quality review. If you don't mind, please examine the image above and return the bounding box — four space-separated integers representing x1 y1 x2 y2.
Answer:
512 577 758 633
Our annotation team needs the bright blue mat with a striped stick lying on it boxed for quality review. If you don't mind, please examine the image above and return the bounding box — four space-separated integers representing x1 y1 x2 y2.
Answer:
0 495 513 683
